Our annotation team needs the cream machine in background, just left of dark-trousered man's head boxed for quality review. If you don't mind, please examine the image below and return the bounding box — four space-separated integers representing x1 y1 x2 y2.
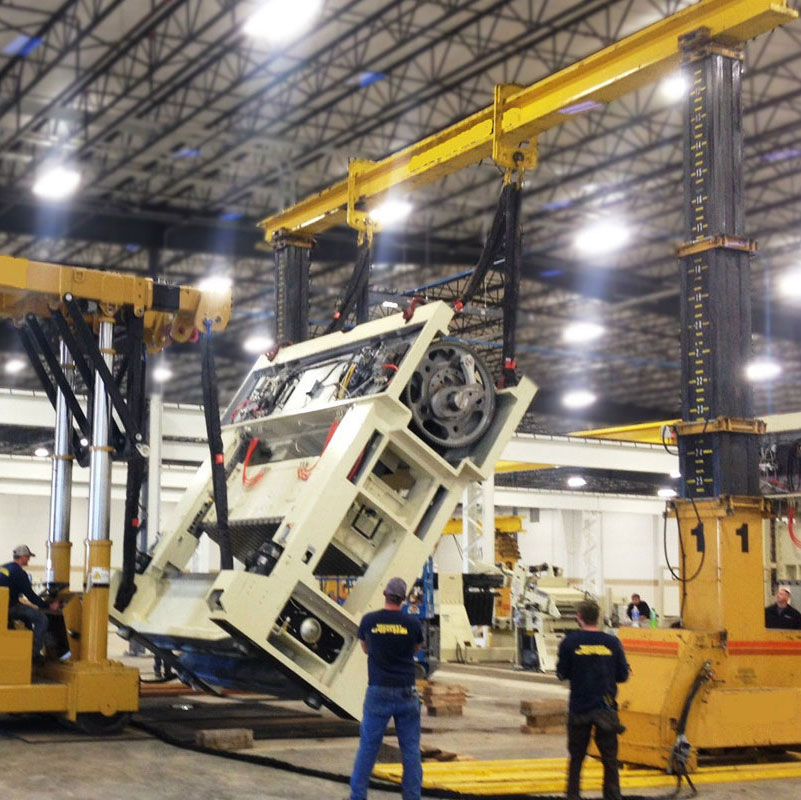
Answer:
512 562 588 672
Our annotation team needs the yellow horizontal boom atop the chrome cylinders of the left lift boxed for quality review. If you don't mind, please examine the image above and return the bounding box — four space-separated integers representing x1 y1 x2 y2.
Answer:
0 256 231 352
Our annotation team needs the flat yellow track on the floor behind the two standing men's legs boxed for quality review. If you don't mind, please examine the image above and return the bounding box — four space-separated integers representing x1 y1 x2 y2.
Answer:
373 754 801 797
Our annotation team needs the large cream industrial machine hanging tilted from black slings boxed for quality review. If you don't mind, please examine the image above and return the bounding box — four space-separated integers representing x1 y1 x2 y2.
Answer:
111 303 536 718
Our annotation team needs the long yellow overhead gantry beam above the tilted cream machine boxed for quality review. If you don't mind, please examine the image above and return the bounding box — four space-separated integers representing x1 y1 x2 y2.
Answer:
259 0 798 244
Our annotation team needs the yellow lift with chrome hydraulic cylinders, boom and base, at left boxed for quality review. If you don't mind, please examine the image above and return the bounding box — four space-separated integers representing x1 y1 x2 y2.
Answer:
0 256 231 732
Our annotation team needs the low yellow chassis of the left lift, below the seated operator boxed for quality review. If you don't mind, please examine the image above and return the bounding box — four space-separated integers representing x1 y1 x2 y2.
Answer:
0 661 139 721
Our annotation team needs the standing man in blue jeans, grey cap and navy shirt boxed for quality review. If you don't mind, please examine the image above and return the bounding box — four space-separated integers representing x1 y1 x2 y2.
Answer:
350 578 423 800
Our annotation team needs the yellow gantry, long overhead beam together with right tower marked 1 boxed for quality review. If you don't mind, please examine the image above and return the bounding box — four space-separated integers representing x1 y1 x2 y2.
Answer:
261 0 801 771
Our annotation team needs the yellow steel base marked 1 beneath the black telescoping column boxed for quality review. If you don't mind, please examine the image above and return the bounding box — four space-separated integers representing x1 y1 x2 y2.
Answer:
618 497 801 770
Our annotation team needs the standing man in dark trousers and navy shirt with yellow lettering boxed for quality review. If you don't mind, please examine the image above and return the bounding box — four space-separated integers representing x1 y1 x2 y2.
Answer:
556 600 629 800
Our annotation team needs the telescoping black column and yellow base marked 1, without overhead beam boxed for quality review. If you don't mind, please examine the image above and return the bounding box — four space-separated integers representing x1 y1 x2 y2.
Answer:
618 26 801 774
